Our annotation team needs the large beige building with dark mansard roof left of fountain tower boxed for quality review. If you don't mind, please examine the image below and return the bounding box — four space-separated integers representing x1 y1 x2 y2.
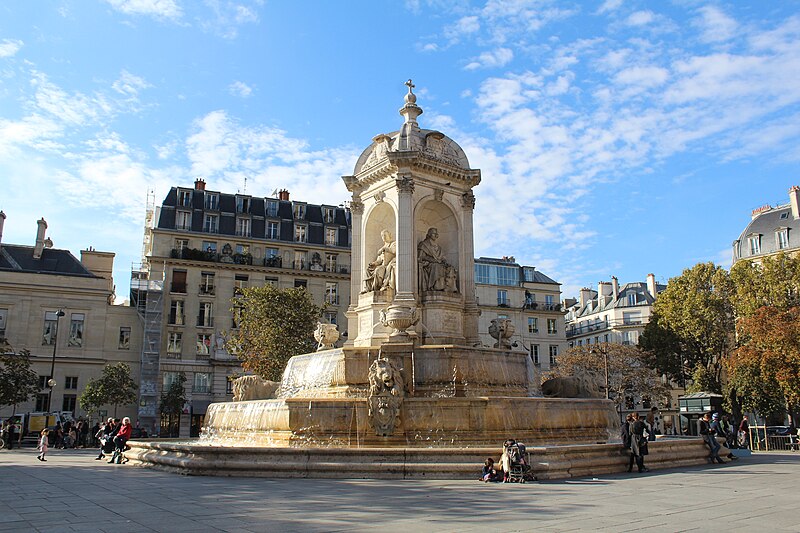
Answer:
131 180 350 433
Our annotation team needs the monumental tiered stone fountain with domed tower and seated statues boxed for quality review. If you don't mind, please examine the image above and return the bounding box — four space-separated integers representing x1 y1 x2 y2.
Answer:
129 80 716 477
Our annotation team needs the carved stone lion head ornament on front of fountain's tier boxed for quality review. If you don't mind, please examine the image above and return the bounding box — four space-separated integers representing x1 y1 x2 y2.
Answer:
367 359 404 437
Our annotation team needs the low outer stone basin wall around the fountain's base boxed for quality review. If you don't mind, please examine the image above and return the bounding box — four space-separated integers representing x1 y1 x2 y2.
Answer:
126 439 720 480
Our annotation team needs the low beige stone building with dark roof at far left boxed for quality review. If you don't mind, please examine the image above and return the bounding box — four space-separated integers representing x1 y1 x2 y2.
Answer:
0 213 142 426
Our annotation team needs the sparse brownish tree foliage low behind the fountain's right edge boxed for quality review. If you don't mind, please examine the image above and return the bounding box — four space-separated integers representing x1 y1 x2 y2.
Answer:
548 343 670 414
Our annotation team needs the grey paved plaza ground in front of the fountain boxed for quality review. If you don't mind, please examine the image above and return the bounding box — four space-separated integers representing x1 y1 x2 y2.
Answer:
0 449 800 533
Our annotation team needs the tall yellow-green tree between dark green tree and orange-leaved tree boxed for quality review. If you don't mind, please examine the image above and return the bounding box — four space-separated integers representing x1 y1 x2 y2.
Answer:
648 263 735 391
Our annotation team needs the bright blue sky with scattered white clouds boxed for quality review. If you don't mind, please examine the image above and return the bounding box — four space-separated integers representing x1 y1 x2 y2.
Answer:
0 0 800 297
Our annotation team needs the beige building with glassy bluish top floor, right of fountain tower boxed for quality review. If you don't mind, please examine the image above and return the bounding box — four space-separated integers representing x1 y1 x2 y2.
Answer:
475 257 567 370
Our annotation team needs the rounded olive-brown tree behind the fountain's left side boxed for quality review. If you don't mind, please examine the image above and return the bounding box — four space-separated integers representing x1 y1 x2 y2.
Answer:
226 285 324 381
